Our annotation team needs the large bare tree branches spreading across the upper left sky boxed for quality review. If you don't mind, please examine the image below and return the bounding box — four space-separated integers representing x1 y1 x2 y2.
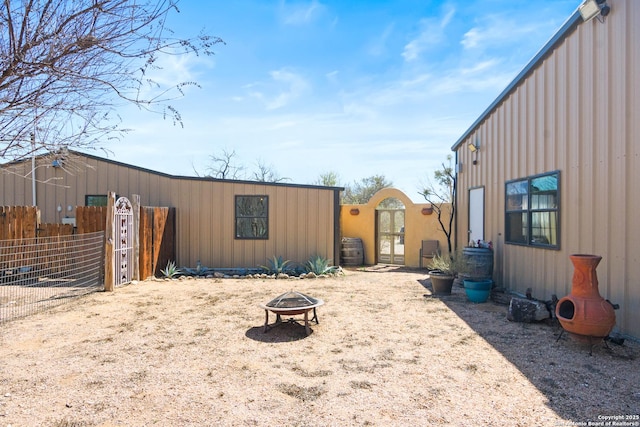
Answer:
0 0 222 160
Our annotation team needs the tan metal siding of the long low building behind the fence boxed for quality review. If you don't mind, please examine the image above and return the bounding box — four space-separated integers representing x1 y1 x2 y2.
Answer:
0 154 338 268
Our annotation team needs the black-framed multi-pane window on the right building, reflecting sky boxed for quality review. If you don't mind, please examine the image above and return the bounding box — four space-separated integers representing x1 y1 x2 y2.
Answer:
505 171 560 249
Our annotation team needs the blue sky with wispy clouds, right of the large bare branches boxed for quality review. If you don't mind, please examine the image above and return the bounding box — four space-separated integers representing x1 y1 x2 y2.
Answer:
106 0 580 202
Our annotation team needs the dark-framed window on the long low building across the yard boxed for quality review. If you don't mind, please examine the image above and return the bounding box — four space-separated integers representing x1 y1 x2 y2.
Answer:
235 196 269 239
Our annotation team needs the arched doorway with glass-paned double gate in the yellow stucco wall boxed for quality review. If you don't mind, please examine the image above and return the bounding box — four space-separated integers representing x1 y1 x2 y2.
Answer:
376 197 406 265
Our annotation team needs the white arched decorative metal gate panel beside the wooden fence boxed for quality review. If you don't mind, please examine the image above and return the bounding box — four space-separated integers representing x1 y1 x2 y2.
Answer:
113 197 133 287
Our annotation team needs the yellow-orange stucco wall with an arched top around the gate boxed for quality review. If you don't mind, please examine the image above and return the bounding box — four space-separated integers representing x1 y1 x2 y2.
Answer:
340 188 449 267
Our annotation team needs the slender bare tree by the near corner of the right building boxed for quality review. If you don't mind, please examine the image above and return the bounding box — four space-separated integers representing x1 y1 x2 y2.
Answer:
418 155 456 254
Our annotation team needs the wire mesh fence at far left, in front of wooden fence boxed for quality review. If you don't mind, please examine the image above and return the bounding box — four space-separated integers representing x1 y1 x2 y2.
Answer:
0 232 104 324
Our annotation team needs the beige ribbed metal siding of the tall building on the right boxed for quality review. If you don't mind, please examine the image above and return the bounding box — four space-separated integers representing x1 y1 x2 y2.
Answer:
457 0 640 337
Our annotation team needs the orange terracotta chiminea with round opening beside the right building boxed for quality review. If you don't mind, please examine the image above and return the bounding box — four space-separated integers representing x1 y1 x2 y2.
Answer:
556 254 616 338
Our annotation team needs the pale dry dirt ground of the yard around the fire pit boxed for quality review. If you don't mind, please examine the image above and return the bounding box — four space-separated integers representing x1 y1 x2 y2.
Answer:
0 267 640 427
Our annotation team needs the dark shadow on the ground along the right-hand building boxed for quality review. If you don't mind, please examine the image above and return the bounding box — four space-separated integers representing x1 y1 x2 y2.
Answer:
419 278 640 425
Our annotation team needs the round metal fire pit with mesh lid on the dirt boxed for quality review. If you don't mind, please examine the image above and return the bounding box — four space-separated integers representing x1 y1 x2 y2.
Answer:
260 291 324 335
